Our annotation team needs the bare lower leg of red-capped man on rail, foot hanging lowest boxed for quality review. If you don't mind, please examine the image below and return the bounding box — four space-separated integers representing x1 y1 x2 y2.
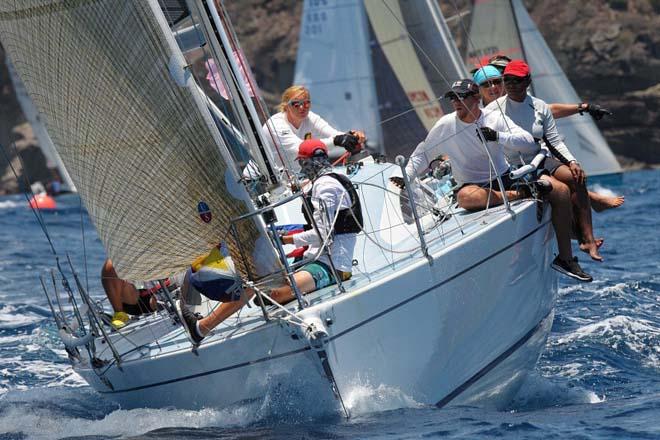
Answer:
553 165 603 261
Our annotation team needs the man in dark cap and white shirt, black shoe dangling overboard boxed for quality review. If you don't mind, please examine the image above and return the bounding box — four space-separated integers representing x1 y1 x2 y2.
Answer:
406 79 592 281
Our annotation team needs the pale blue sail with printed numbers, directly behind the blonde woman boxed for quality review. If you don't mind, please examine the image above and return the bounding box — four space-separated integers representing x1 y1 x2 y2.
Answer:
293 0 382 151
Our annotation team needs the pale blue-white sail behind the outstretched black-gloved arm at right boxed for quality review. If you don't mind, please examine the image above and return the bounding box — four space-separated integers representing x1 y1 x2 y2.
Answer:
512 0 621 176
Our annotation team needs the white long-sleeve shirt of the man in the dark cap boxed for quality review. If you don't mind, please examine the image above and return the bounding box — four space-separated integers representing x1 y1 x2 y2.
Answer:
406 112 536 185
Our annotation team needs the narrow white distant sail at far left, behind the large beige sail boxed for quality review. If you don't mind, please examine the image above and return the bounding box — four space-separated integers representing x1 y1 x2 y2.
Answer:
5 57 76 192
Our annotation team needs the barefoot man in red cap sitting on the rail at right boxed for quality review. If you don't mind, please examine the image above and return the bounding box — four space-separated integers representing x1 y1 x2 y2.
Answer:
484 60 609 261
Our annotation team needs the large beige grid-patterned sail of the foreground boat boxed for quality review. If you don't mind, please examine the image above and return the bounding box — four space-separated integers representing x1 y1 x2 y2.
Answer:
0 0 277 280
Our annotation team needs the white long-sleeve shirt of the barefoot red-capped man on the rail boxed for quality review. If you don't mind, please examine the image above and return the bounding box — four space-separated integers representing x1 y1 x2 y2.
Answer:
484 95 575 165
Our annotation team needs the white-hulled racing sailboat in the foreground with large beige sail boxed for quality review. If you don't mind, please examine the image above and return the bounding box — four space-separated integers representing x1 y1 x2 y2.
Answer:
0 0 557 416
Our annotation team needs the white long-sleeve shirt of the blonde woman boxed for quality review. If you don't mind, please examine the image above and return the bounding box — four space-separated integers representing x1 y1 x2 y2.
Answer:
263 111 342 169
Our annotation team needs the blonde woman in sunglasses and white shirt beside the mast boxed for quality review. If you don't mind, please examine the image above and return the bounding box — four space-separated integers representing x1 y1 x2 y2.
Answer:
263 85 366 169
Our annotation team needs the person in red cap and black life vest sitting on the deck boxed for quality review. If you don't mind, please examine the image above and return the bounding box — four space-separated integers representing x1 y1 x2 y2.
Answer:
177 139 362 344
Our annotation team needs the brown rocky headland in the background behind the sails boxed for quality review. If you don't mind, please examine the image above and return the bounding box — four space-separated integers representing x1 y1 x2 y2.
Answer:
0 0 660 194
